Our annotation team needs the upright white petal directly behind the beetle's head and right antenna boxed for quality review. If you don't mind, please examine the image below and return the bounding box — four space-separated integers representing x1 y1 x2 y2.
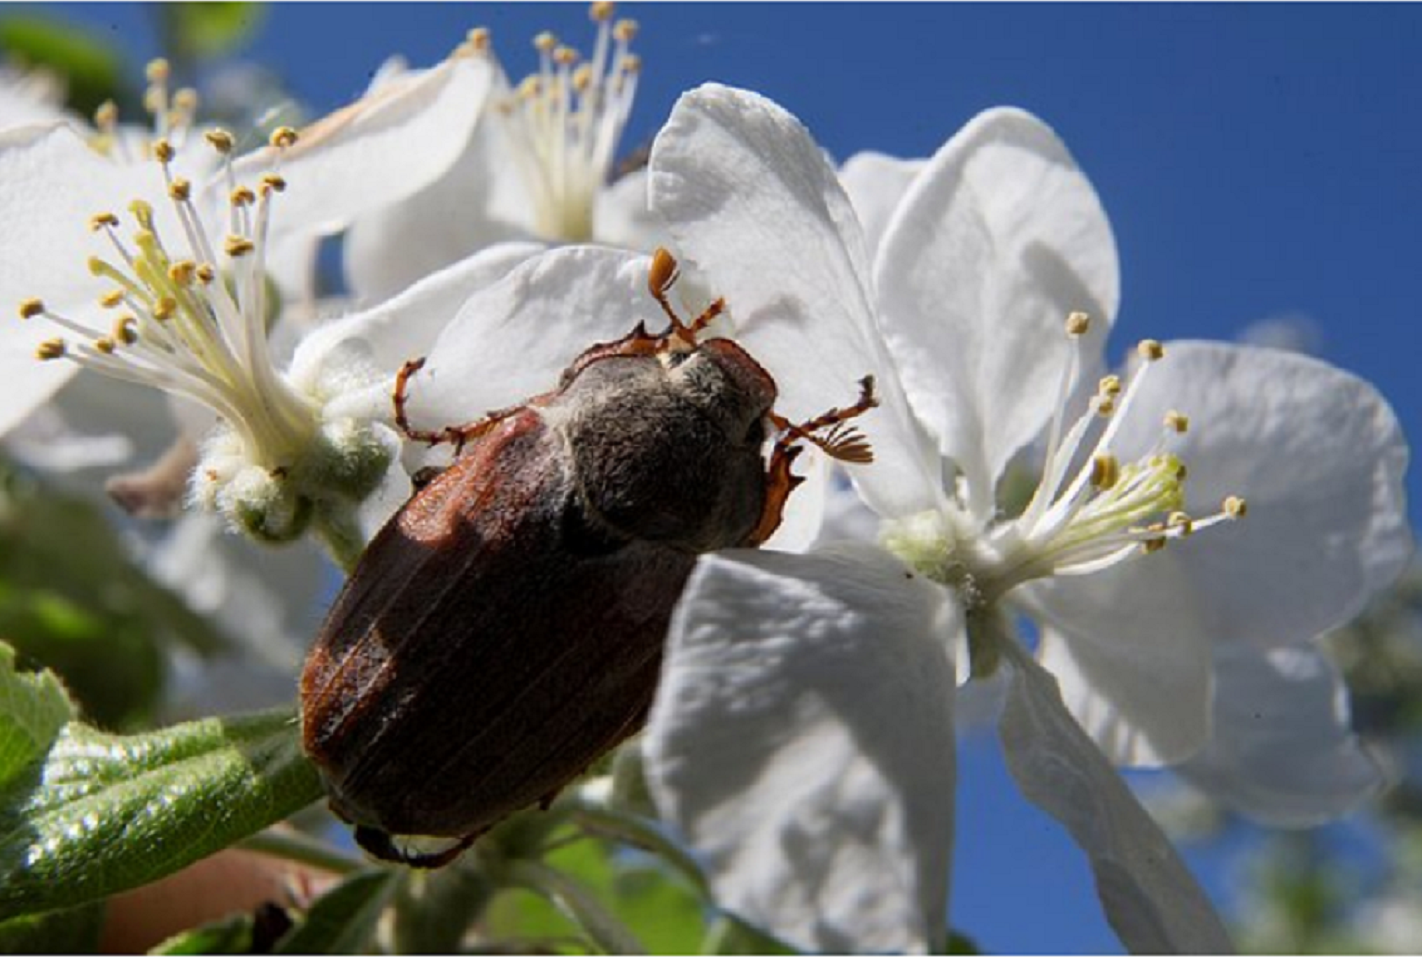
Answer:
650 84 941 515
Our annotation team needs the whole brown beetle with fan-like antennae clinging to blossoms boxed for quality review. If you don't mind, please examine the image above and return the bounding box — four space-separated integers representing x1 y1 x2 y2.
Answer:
301 249 875 866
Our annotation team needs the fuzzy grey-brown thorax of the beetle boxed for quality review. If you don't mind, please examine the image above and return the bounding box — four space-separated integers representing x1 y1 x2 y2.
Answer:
539 340 775 552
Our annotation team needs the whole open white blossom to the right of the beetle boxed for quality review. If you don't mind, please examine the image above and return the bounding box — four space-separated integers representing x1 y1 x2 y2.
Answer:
646 85 1411 951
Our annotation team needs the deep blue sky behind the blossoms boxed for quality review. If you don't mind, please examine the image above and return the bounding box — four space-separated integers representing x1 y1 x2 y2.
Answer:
41 3 1422 951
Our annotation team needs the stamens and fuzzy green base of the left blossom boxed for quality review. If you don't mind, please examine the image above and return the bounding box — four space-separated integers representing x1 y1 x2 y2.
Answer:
20 128 398 555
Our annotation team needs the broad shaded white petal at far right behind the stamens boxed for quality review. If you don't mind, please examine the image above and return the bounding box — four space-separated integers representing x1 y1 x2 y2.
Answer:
1119 343 1412 647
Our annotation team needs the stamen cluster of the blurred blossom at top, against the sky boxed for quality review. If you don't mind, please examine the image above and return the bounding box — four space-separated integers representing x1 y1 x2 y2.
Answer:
502 3 641 242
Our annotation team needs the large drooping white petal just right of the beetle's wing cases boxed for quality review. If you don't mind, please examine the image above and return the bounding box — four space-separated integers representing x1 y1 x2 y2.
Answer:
644 547 961 953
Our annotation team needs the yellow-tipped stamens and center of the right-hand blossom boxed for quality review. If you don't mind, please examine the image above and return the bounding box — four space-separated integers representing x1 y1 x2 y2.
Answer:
884 313 1244 613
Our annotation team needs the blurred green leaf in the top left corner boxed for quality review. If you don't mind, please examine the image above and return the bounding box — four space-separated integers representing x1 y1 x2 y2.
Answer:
0 13 127 115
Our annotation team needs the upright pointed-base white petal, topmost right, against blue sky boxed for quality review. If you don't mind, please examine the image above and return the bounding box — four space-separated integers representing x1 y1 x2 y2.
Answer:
875 108 1119 509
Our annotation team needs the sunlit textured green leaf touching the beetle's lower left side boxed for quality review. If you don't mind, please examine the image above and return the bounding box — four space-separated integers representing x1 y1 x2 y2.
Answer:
0 702 321 919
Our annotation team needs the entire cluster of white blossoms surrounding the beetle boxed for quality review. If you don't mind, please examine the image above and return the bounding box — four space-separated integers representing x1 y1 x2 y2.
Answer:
0 4 1412 953
